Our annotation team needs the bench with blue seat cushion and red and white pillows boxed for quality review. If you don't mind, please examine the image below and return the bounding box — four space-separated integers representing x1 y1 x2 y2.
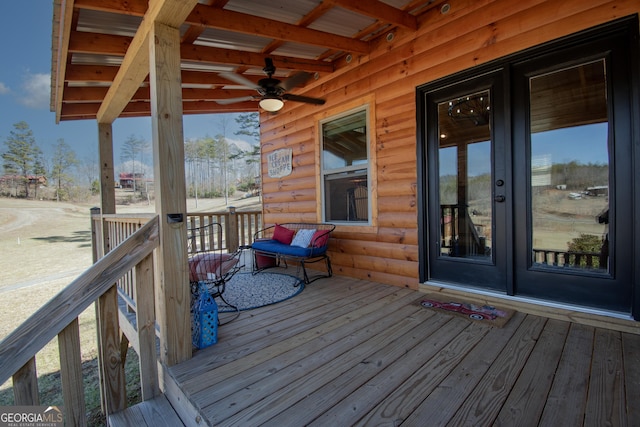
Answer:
251 222 336 284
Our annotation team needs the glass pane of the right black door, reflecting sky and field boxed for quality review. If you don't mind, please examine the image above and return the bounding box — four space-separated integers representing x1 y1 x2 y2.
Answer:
529 60 610 272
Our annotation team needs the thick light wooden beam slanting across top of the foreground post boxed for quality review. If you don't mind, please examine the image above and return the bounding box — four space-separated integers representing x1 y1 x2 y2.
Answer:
96 0 198 123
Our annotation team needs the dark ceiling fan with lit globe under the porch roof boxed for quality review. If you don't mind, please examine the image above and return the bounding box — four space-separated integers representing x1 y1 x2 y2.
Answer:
216 58 325 113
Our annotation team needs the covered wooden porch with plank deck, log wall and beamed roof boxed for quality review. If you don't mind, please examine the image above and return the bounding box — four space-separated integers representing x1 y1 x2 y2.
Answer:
15 0 640 425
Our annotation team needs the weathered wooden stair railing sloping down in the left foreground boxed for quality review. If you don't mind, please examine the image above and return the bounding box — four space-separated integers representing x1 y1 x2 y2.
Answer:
0 217 159 426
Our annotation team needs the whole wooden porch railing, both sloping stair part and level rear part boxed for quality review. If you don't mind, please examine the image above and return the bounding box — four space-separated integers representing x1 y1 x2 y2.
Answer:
0 208 262 426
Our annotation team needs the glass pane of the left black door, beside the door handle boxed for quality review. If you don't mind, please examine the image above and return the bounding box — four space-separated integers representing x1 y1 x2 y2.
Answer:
438 91 493 262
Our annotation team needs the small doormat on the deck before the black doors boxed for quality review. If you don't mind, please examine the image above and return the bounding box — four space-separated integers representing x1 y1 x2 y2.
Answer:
417 293 514 328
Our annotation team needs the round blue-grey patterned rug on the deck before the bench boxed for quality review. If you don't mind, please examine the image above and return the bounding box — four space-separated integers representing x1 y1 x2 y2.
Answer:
216 271 304 313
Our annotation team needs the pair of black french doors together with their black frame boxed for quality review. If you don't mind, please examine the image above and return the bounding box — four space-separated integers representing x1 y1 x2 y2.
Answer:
418 20 638 313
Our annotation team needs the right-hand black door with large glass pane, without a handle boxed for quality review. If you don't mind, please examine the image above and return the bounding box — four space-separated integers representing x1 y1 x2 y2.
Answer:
512 39 634 312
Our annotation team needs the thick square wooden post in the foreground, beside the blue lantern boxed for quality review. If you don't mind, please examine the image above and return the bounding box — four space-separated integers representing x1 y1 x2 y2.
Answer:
149 22 191 366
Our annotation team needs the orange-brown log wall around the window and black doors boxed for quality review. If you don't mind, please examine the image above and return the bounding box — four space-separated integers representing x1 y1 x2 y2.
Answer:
261 0 640 289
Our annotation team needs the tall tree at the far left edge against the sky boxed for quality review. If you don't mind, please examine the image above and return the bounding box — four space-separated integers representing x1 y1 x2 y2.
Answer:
2 121 42 198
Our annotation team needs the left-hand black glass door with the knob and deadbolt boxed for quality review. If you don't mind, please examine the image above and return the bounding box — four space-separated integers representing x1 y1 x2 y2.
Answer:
427 70 510 291
